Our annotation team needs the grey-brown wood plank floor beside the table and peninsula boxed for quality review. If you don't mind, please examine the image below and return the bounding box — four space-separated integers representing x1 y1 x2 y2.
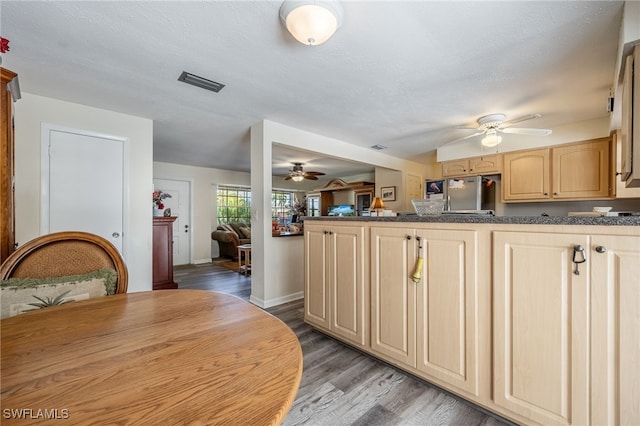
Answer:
174 262 510 426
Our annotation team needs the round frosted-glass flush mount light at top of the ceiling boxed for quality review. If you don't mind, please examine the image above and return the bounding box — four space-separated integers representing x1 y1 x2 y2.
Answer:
280 0 342 46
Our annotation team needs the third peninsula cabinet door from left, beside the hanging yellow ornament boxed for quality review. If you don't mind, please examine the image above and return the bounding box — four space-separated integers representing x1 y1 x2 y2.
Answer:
370 227 416 367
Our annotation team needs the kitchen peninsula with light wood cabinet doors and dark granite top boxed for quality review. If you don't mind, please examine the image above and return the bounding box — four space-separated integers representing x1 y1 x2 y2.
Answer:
304 214 640 426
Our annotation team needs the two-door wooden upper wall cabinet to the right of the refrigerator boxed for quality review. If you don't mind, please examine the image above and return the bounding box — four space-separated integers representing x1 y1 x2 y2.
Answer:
502 138 614 202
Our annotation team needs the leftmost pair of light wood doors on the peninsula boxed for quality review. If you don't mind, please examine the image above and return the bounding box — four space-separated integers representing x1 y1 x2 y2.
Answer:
304 221 369 347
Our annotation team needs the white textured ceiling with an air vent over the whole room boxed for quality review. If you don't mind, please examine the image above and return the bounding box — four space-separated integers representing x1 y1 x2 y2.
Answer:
0 0 623 180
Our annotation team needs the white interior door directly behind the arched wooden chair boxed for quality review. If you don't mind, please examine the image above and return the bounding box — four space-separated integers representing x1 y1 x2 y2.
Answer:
41 125 128 255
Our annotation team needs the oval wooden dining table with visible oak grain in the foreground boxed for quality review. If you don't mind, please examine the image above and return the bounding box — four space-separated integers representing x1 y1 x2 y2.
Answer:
0 290 302 425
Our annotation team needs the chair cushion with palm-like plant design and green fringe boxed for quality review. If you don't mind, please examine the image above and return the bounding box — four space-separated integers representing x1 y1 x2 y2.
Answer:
0 269 117 318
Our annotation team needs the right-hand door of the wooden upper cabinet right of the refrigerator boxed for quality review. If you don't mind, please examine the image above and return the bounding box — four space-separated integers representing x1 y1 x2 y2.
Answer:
551 138 610 199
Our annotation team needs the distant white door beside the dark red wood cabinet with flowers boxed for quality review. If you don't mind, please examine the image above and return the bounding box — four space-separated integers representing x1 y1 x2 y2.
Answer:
153 179 191 265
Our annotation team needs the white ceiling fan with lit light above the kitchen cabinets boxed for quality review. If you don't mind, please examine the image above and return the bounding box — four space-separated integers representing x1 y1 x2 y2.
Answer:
444 114 551 148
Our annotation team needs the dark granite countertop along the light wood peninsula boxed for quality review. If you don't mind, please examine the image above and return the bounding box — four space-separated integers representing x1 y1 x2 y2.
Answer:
304 214 640 226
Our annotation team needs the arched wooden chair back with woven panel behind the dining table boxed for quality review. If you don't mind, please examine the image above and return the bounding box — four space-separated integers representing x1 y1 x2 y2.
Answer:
0 231 129 293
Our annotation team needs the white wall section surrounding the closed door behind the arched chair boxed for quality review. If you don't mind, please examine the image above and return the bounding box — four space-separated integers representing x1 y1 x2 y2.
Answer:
15 92 153 292
